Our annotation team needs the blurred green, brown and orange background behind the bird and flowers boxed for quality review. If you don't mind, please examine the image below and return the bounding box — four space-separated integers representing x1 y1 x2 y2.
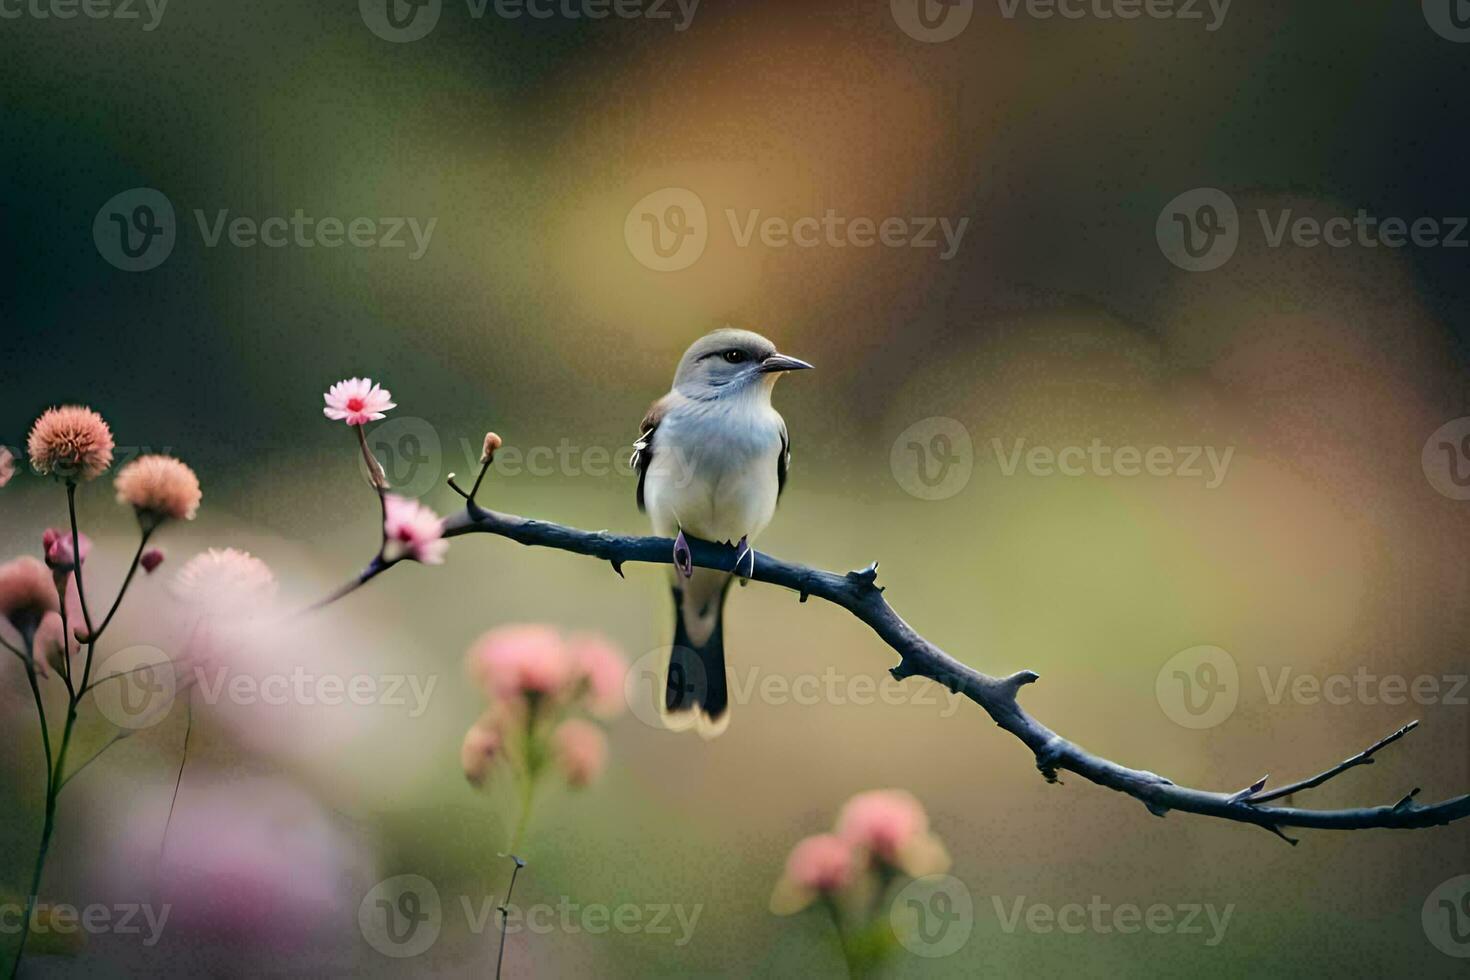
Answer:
0 0 1470 977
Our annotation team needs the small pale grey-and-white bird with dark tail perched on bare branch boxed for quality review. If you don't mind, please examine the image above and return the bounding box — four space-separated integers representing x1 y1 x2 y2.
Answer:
632 329 811 738
